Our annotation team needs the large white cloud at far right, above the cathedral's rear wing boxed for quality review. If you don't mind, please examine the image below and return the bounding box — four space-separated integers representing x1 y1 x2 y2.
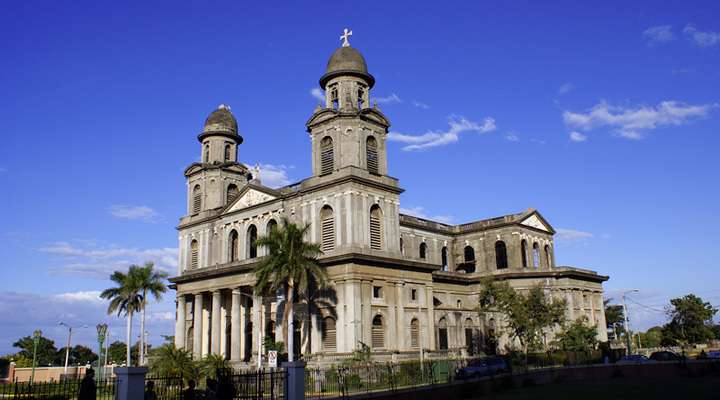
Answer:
563 101 720 139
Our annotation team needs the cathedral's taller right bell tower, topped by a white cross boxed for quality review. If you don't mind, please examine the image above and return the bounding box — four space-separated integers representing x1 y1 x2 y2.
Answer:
306 30 390 177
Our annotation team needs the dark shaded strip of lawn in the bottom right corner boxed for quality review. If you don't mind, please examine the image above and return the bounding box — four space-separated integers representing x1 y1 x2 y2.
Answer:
466 376 720 400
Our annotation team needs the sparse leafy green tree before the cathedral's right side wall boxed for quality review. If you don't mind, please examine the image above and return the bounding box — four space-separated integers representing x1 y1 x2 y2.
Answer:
479 279 565 366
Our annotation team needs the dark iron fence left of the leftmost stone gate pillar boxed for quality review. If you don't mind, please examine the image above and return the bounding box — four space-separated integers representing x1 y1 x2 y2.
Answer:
0 378 117 400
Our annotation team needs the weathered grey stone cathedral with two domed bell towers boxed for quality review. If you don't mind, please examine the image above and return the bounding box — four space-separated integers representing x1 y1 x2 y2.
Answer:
171 37 608 365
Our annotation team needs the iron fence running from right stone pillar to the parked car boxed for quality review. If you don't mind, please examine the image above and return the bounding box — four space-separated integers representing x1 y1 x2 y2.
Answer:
305 360 465 399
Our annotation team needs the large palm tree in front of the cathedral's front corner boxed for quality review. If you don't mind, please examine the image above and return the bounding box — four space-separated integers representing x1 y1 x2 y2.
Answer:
255 217 327 352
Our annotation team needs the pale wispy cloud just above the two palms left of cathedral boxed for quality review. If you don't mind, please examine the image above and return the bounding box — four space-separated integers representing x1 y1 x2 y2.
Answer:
38 241 178 279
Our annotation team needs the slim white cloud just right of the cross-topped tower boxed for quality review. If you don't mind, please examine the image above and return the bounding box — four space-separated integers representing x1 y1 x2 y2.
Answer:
388 115 496 151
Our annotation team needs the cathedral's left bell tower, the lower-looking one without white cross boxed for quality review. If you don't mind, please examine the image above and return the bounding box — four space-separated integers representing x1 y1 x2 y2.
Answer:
185 104 249 216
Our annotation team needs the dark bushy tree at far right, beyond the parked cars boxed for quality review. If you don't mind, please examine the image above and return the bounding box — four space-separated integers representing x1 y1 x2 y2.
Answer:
663 294 718 344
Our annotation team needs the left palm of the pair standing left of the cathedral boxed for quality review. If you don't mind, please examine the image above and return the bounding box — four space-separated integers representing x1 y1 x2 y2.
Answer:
100 265 143 367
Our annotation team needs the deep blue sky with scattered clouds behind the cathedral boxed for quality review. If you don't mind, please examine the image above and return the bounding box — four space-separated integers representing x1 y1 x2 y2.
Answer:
0 1 720 354
